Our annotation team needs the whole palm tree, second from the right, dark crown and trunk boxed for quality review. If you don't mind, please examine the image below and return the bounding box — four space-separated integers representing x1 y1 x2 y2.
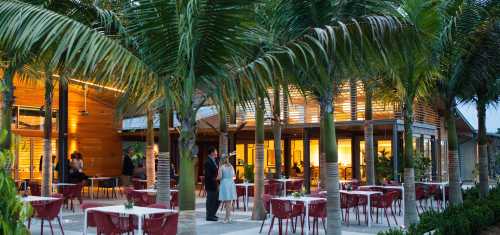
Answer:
433 1 498 205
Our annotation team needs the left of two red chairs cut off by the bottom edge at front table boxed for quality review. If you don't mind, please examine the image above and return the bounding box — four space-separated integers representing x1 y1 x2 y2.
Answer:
94 211 134 235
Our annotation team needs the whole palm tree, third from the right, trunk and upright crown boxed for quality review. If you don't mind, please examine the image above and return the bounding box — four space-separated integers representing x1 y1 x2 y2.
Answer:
380 0 442 226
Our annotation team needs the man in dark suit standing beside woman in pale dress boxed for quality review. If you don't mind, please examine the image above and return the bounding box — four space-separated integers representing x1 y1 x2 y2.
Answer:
204 146 219 221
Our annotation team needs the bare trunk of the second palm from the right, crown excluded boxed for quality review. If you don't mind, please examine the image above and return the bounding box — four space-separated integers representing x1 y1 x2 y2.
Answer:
445 104 463 205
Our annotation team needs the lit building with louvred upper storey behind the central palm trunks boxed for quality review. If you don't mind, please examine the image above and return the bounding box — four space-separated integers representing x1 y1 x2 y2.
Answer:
122 83 472 184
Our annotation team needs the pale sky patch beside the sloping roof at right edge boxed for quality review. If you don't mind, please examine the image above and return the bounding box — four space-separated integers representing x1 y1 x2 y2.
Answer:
458 104 500 133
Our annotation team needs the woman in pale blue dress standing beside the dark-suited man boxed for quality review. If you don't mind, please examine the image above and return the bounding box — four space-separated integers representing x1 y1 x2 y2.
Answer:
217 157 236 223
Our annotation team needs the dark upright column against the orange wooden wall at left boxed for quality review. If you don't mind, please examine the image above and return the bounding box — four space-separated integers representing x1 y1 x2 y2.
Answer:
57 81 68 183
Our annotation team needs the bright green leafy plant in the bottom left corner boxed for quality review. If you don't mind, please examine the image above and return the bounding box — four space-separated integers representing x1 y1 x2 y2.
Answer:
0 147 31 235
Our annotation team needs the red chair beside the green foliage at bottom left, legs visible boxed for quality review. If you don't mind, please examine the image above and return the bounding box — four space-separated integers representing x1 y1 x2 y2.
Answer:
28 198 64 235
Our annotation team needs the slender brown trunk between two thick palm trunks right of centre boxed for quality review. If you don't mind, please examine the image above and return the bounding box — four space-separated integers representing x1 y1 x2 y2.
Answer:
364 82 376 185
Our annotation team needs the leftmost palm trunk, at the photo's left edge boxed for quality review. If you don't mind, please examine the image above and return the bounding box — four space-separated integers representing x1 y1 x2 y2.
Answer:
0 65 16 152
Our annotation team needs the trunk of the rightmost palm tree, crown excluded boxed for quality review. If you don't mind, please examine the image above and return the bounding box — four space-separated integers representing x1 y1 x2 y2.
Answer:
476 97 489 198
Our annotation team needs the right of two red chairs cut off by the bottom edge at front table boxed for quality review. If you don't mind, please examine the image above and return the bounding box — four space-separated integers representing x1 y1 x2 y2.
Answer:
144 213 179 235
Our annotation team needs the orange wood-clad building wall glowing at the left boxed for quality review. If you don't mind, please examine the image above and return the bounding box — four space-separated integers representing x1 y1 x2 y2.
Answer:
0 75 122 179
